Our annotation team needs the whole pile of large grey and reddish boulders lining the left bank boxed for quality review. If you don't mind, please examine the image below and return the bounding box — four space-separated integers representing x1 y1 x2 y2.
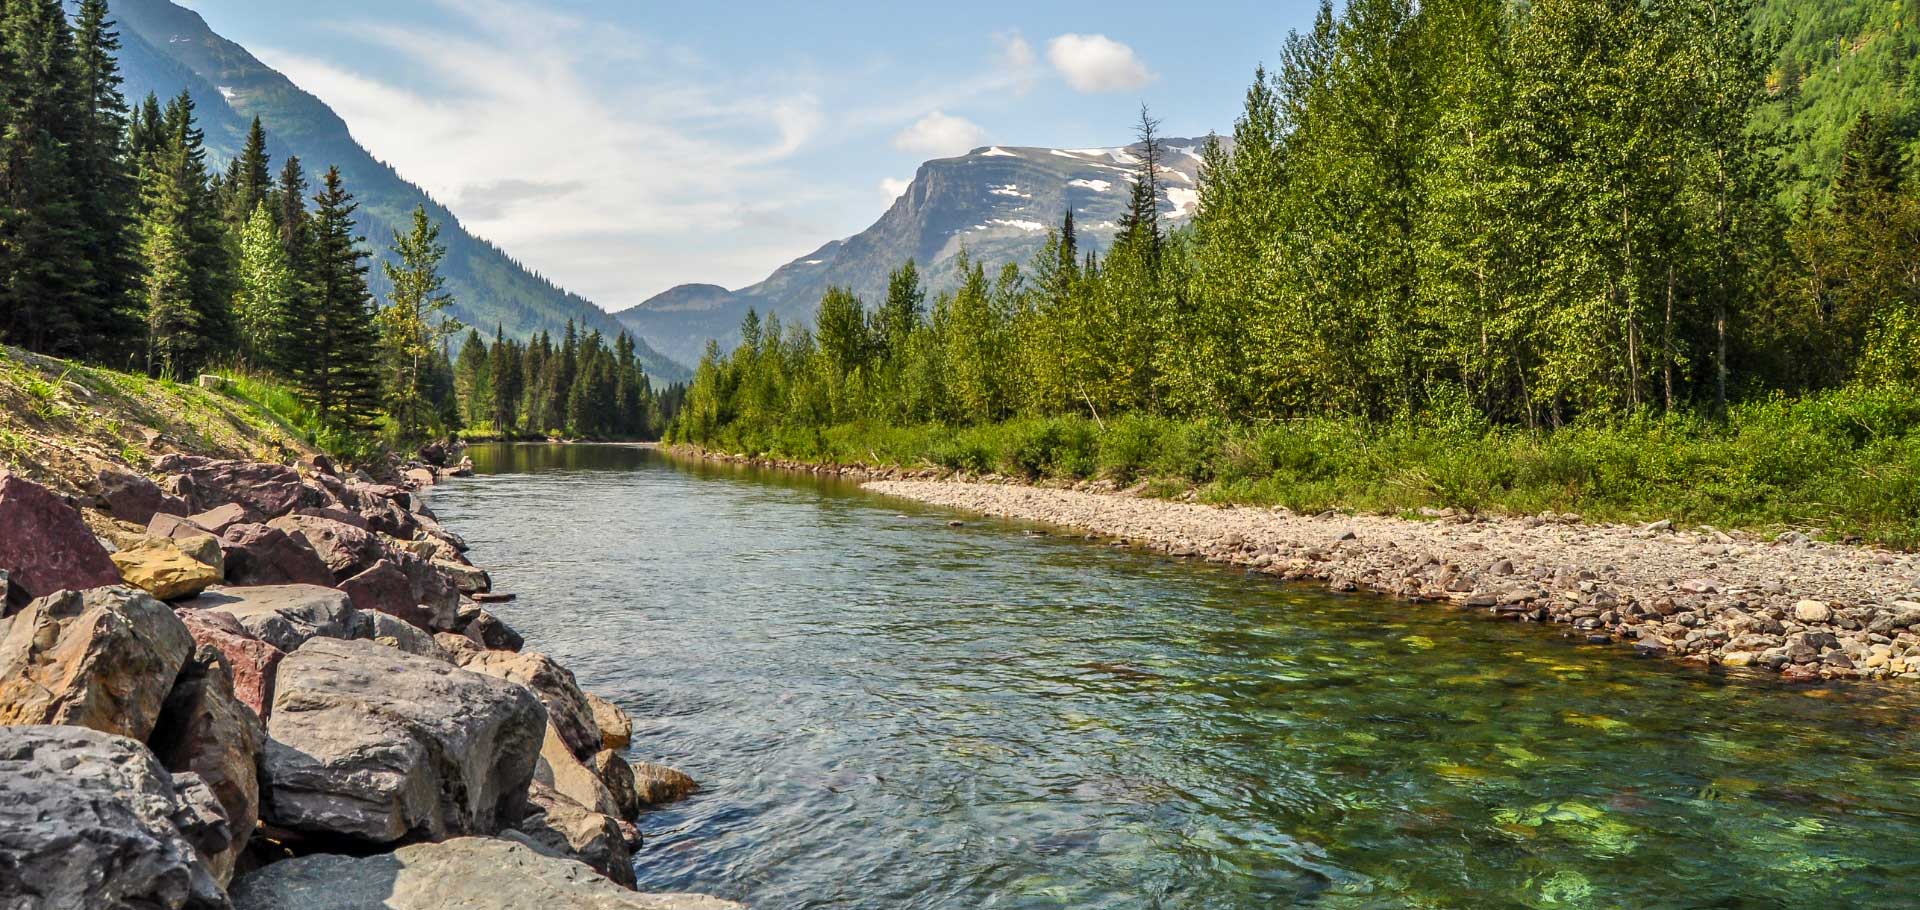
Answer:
0 455 739 910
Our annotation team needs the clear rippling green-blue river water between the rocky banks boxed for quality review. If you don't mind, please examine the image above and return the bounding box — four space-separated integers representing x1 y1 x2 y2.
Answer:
432 445 1920 910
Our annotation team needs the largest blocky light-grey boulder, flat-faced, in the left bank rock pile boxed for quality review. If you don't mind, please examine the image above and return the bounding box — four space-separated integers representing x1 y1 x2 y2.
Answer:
261 639 545 847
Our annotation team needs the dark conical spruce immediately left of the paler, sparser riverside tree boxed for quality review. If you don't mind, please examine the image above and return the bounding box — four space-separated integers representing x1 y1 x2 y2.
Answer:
288 167 380 432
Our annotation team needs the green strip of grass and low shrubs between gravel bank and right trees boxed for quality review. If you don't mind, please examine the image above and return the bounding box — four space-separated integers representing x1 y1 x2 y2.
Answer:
695 390 1920 549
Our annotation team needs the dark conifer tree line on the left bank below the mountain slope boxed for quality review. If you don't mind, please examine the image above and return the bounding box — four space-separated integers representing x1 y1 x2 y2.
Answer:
0 0 657 442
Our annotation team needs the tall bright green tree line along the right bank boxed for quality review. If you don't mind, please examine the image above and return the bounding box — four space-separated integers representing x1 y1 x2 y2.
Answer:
676 0 1920 440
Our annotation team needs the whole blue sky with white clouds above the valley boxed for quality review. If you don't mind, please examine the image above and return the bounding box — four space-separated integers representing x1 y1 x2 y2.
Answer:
180 0 1317 311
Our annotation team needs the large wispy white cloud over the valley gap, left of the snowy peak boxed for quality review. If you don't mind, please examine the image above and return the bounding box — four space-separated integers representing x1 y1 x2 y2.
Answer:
255 0 831 309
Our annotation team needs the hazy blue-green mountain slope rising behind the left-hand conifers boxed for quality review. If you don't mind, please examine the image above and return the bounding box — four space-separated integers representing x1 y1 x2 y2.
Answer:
111 0 689 380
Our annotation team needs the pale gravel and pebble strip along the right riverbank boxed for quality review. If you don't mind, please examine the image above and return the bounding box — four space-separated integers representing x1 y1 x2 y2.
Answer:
864 470 1920 680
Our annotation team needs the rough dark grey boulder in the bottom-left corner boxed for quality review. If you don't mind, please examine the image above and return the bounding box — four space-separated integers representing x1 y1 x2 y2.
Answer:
0 726 228 910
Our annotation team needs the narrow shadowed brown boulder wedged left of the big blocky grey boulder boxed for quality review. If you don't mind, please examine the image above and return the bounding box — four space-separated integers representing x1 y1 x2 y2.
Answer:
148 645 265 885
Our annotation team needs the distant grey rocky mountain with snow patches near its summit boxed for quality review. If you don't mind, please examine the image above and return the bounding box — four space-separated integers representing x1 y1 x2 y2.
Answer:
618 138 1206 363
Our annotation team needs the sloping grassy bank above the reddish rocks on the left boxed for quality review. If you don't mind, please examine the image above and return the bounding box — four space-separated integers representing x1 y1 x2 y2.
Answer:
0 347 313 491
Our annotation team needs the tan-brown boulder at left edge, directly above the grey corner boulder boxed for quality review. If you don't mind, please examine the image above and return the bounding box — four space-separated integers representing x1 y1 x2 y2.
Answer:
0 587 194 741
